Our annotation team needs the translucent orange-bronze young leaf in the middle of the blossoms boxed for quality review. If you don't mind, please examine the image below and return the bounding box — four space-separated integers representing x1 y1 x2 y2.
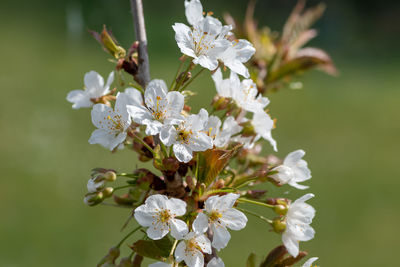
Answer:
197 145 242 186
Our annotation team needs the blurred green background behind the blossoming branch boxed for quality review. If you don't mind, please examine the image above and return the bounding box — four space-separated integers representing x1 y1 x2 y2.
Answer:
0 0 400 267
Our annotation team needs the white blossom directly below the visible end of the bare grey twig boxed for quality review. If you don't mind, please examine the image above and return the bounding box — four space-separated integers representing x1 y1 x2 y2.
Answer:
127 80 184 135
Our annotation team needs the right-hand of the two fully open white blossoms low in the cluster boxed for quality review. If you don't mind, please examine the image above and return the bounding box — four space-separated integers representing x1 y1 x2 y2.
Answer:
193 193 247 250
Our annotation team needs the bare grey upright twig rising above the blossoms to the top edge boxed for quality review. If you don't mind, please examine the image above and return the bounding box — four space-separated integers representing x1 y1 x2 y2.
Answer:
130 0 150 88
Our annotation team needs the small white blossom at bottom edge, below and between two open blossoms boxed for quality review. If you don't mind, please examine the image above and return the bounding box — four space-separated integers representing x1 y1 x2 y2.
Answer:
174 232 211 267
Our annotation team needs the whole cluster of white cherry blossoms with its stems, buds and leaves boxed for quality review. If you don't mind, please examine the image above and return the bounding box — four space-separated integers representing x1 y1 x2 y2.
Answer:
67 0 332 267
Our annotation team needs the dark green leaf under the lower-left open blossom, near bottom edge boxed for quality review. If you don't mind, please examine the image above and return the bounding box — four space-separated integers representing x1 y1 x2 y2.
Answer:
131 236 173 261
